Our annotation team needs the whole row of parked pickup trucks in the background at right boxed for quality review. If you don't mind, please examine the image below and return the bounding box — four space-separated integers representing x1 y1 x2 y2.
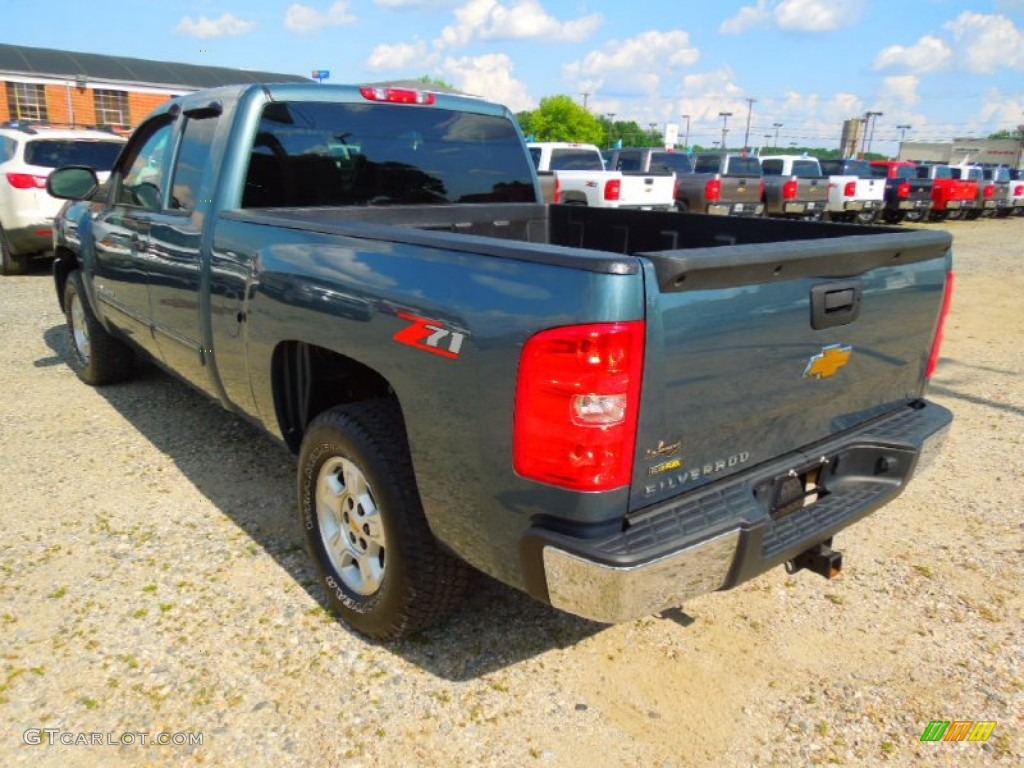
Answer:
529 142 1024 224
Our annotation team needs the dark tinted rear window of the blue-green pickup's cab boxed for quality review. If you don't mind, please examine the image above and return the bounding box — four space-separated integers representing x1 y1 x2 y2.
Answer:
242 101 540 207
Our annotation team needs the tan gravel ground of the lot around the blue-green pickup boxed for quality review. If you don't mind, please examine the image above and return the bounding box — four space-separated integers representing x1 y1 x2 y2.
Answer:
0 218 1024 768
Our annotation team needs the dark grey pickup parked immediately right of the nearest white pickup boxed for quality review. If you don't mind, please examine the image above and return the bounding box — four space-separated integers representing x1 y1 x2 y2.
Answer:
676 153 764 216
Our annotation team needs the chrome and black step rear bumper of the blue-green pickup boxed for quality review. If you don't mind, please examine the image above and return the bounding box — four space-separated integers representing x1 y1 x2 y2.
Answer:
522 400 952 623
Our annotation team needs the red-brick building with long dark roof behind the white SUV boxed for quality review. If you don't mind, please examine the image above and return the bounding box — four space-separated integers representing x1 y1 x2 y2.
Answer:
0 44 311 133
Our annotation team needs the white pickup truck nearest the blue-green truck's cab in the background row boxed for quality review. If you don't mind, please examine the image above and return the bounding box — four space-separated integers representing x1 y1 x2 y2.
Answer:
526 141 676 211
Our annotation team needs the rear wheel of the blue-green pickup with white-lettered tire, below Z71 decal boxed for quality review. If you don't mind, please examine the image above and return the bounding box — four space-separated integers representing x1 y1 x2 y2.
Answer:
298 400 468 640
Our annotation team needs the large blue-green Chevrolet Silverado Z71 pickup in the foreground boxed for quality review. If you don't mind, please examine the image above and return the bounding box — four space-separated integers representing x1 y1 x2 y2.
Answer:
47 83 952 639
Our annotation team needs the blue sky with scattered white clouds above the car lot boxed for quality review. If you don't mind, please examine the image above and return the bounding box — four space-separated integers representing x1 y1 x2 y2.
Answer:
0 0 1024 153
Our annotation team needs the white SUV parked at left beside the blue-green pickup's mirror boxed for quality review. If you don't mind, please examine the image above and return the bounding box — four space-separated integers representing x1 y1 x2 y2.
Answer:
0 123 125 274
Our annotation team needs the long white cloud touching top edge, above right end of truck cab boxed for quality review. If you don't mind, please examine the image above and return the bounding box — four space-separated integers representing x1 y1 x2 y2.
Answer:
437 0 603 48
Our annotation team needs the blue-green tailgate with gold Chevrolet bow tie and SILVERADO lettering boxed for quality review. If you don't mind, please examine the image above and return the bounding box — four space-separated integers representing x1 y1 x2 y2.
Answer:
630 224 951 511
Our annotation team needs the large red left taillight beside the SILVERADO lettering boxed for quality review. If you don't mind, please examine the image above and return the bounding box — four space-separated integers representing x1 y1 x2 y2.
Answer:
512 321 646 490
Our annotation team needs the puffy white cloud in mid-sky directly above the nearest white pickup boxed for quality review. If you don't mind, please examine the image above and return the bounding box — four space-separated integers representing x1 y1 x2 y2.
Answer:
563 30 700 95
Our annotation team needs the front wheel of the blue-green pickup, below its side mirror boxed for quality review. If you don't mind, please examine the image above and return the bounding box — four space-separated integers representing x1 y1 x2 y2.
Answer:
63 270 135 386
